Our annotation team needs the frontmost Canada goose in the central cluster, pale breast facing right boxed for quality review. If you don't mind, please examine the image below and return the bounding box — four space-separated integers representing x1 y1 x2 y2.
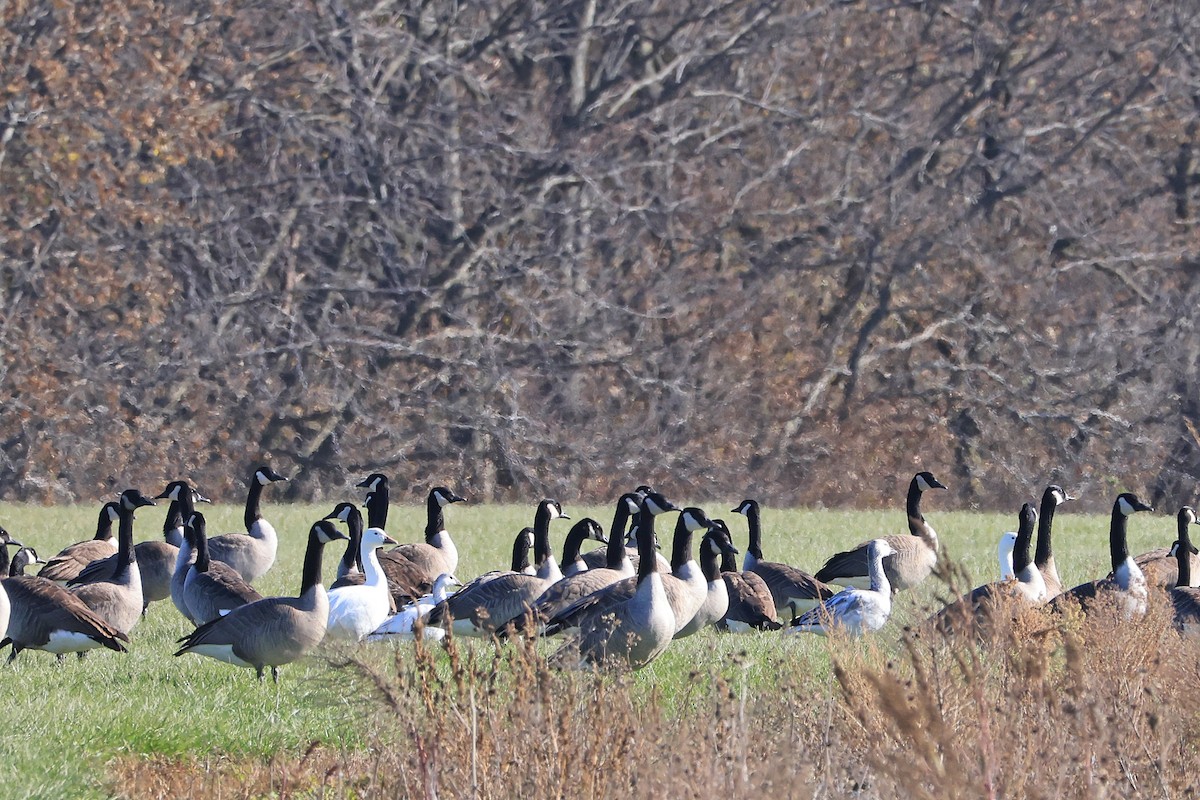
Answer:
552 495 677 669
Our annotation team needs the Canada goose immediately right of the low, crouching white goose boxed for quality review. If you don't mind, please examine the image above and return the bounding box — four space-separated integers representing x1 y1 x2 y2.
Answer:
428 499 568 636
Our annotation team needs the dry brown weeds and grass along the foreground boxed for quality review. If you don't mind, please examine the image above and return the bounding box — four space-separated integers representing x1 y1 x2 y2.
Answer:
113 575 1200 799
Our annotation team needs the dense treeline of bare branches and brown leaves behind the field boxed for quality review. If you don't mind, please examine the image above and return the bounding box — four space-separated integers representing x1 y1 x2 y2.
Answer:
0 0 1200 509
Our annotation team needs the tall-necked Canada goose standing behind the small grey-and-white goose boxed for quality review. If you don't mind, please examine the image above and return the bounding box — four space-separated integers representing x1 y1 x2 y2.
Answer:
816 473 946 591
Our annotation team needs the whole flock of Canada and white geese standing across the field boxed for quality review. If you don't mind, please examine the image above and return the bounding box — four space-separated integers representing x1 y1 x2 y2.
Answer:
0 467 1200 681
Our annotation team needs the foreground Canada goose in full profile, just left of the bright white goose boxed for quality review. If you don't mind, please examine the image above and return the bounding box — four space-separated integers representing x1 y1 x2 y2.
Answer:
175 519 346 682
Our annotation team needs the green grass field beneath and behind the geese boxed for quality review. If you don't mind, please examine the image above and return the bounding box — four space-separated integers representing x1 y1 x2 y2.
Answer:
0 495 1175 798
